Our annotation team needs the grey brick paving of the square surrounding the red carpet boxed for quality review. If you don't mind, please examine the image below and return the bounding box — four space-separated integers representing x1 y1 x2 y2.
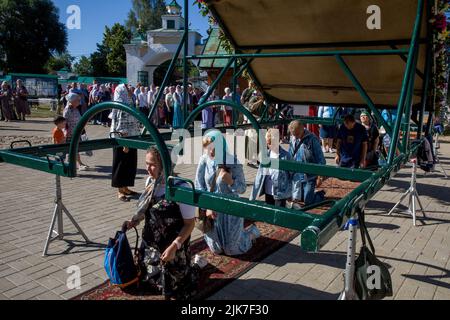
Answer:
0 119 450 300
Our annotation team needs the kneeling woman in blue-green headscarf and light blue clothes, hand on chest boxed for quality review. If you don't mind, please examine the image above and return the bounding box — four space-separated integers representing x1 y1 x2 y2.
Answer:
195 130 260 256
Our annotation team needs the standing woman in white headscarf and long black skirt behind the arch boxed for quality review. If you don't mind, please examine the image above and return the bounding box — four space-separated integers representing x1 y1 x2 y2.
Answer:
111 84 140 202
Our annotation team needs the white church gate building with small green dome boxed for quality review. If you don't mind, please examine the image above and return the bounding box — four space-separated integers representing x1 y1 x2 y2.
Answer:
125 0 203 86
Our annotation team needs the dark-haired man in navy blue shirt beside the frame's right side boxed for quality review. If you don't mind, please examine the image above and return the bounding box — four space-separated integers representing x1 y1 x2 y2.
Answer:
336 115 369 169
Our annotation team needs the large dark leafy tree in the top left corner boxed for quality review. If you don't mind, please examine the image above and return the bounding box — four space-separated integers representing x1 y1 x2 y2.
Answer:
0 0 67 73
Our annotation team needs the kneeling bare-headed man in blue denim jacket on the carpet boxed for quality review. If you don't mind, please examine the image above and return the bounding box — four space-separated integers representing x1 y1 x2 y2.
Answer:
289 120 326 206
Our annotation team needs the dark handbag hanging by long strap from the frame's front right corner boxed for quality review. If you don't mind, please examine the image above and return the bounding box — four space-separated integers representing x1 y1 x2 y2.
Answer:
355 212 393 300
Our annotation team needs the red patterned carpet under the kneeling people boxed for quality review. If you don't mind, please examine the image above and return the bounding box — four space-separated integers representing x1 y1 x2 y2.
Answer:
74 178 359 300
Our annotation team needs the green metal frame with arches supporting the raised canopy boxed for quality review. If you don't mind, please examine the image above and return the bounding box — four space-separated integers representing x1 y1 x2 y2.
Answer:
0 0 432 255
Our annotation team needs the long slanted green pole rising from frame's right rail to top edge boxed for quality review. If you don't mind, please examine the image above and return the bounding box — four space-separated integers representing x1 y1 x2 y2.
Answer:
388 0 424 165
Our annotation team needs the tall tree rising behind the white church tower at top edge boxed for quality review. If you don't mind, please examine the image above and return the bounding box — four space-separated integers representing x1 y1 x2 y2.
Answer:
125 0 166 34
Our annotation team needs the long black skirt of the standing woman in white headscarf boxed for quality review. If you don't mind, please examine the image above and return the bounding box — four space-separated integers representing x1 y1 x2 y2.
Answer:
112 147 137 188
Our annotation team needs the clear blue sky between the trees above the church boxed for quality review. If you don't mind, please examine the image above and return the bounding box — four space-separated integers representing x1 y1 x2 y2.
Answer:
53 0 208 58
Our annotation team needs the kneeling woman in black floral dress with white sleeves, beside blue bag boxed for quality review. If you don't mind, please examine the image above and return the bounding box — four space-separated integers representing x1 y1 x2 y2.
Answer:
127 147 196 300
